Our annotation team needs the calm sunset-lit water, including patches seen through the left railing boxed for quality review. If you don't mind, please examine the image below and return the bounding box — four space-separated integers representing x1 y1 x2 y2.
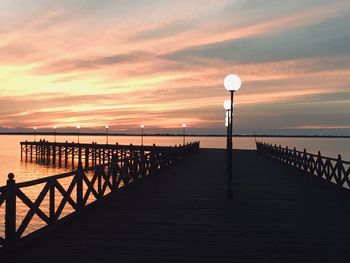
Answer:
0 135 350 240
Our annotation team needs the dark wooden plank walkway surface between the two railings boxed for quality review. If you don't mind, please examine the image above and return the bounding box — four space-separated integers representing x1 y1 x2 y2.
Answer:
0 149 350 263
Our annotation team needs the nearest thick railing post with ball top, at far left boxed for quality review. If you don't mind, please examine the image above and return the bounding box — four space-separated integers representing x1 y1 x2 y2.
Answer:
5 173 16 245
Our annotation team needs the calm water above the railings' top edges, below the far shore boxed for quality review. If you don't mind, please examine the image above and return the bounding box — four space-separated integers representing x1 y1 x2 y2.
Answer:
0 135 350 185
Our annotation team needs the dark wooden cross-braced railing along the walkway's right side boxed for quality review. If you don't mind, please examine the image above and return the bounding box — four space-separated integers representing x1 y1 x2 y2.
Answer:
256 142 350 189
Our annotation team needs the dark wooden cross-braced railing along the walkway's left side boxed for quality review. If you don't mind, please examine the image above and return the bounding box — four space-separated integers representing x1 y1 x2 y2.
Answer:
0 142 199 246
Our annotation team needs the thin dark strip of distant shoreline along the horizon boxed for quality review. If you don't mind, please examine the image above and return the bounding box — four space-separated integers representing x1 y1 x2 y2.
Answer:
0 132 350 138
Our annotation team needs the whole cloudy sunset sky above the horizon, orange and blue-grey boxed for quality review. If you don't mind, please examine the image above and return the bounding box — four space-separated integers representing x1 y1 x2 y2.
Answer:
0 0 350 135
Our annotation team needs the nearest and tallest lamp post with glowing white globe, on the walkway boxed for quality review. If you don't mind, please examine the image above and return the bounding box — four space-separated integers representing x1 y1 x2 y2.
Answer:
224 74 241 199
